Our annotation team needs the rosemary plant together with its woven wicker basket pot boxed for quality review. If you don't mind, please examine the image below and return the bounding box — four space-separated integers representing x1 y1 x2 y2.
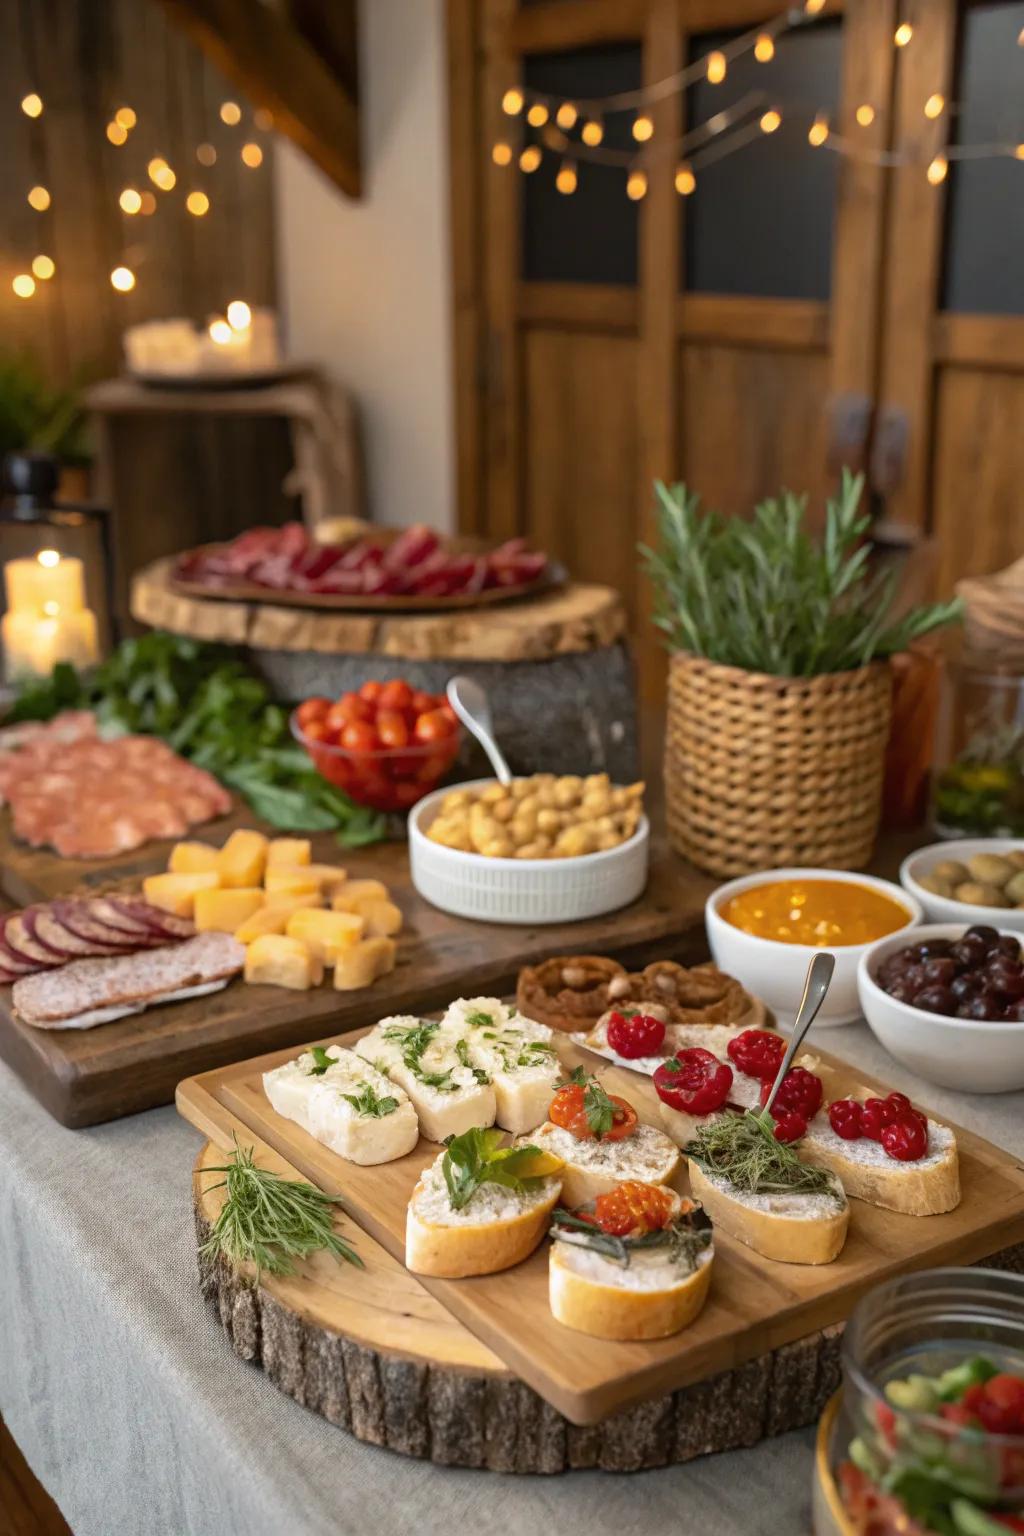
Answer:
642 470 961 876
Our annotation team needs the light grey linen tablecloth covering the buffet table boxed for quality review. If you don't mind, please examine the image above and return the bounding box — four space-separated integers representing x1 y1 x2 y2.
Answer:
0 1025 1024 1536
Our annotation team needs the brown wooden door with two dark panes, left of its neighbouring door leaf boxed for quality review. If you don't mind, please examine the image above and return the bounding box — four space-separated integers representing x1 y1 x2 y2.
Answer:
450 0 895 691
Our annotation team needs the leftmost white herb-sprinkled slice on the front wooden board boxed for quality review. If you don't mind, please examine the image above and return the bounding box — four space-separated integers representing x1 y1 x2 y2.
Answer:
263 1046 419 1167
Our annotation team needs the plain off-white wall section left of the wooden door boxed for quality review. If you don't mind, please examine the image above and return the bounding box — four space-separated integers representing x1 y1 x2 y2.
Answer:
275 0 454 528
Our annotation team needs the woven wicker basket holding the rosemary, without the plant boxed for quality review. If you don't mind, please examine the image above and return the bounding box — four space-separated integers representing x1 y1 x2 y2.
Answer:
665 653 892 876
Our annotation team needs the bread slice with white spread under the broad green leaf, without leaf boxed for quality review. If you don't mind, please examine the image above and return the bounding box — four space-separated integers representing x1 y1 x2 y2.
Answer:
405 1154 562 1279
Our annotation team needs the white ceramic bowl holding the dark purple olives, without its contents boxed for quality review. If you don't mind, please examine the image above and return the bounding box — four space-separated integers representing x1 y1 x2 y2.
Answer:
857 920 1024 1094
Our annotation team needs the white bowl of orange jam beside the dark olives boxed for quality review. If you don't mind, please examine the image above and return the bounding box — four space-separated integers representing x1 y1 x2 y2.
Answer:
705 868 924 1028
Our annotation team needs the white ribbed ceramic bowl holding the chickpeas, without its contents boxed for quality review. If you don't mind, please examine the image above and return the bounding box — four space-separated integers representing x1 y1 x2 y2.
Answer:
408 779 651 926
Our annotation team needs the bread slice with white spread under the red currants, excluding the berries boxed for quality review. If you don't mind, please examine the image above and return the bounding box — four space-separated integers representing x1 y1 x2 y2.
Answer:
800 1109 960 1217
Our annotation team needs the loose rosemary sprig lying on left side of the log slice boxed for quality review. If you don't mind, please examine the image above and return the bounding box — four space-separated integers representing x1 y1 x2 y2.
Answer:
200 1138 364 1284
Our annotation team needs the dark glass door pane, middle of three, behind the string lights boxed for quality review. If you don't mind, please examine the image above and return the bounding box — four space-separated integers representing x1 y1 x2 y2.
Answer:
680 22 843 300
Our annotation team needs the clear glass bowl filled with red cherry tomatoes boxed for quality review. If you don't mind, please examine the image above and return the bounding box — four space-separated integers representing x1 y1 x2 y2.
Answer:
292 677 459 811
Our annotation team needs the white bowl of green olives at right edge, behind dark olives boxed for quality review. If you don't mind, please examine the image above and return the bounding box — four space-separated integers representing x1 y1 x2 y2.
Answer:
900 837 1024 932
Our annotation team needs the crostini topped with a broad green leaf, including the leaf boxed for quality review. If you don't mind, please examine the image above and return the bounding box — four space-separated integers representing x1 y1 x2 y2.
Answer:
405 1126 562 1279
